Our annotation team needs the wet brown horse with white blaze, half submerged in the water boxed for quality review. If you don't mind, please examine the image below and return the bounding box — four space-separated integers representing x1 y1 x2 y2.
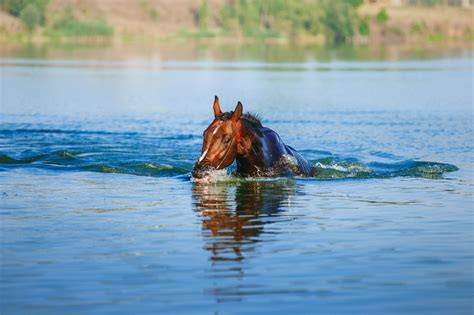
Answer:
192 96 316 178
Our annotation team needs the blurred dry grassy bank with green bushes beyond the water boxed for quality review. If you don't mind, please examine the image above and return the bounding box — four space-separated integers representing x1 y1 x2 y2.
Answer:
0 0 474 46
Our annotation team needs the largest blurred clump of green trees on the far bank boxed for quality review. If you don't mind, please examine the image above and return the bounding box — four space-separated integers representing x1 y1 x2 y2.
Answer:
219 0 362 43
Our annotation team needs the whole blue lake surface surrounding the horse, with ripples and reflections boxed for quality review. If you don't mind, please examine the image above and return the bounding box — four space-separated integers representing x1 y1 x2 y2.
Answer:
0 45 474 314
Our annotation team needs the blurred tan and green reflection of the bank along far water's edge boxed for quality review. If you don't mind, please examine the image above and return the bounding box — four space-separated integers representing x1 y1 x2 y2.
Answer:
0 40 474 63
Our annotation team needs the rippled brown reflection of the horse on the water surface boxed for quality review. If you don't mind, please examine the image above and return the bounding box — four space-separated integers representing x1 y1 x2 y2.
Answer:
193 180 296 265
